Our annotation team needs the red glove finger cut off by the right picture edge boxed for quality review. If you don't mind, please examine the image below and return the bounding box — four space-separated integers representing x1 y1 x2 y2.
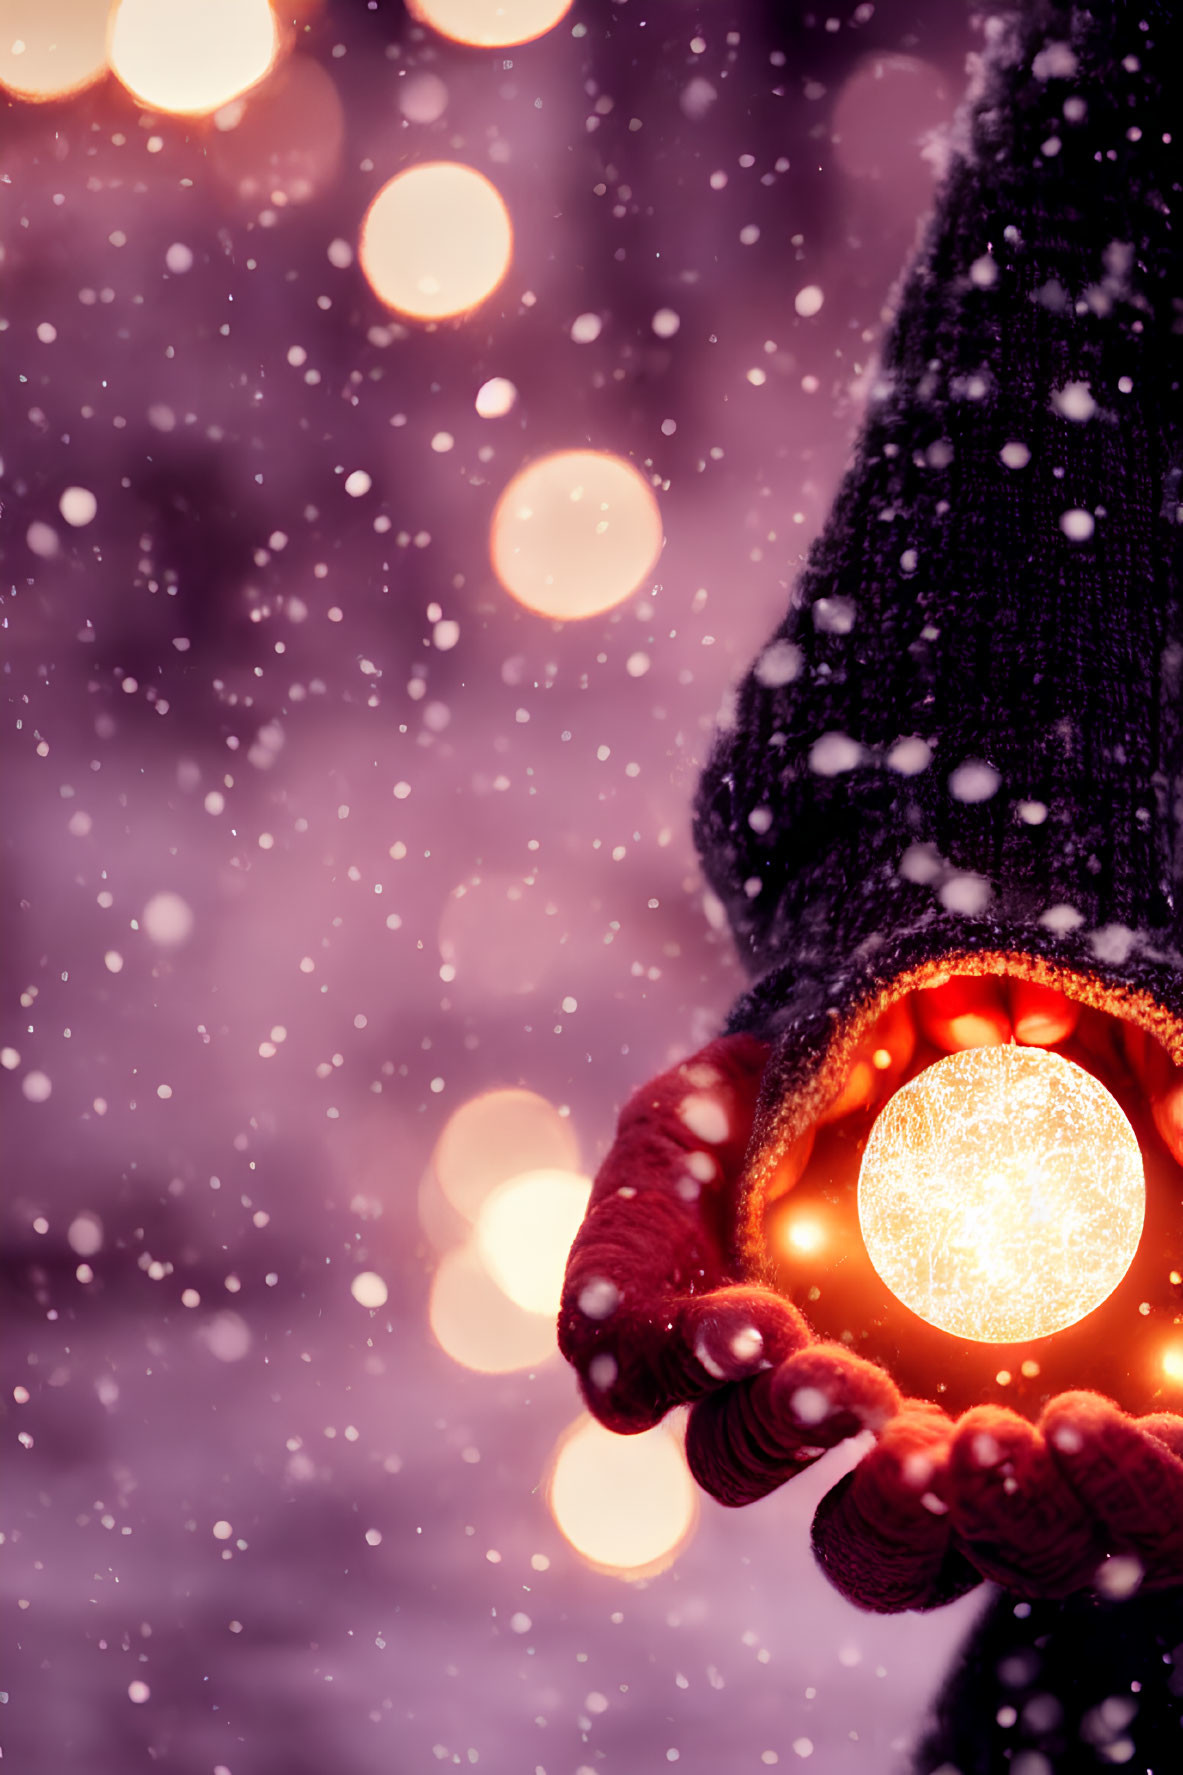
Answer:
1041 1393 1183 1587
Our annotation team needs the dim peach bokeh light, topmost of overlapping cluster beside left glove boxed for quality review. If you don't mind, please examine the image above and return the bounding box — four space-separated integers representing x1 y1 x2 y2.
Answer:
432 1088 579 1219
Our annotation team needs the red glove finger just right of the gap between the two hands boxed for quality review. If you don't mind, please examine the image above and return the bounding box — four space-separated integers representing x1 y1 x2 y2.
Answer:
814 1399 981 1615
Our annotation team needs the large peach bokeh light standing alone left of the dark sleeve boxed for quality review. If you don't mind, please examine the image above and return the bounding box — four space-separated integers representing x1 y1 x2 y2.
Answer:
490 449 663 621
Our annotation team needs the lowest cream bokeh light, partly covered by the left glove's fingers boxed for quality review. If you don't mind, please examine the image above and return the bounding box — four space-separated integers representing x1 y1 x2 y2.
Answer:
547 1416 698 1578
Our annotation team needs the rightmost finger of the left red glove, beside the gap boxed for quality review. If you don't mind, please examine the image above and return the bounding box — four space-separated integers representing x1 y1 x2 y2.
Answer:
686 1344 899 1505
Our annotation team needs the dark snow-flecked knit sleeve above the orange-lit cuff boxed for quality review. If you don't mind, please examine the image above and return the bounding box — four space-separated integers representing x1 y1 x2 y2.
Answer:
696 0 1183 1049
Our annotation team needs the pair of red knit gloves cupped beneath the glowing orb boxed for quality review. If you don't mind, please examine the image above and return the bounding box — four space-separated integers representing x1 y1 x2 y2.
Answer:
560 1035 1183 1612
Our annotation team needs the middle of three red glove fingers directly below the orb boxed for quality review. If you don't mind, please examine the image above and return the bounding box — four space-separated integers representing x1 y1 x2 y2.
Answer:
945 1406 1103 1598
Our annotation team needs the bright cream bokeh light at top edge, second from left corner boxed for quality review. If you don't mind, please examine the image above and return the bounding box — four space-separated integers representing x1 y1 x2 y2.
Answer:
108 0 279 115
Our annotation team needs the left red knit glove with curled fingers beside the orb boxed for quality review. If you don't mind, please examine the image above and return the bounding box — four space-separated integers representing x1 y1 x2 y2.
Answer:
560 1035 899 1503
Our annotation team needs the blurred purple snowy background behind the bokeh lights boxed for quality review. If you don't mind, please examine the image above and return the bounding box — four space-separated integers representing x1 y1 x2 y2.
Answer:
0 0 979 1775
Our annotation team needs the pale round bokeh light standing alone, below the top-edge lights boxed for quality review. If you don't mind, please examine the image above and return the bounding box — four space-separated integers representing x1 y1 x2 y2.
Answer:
357 160 513 321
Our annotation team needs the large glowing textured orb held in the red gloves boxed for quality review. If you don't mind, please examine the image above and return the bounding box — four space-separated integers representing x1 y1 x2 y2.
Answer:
858 1045 1146 1344
